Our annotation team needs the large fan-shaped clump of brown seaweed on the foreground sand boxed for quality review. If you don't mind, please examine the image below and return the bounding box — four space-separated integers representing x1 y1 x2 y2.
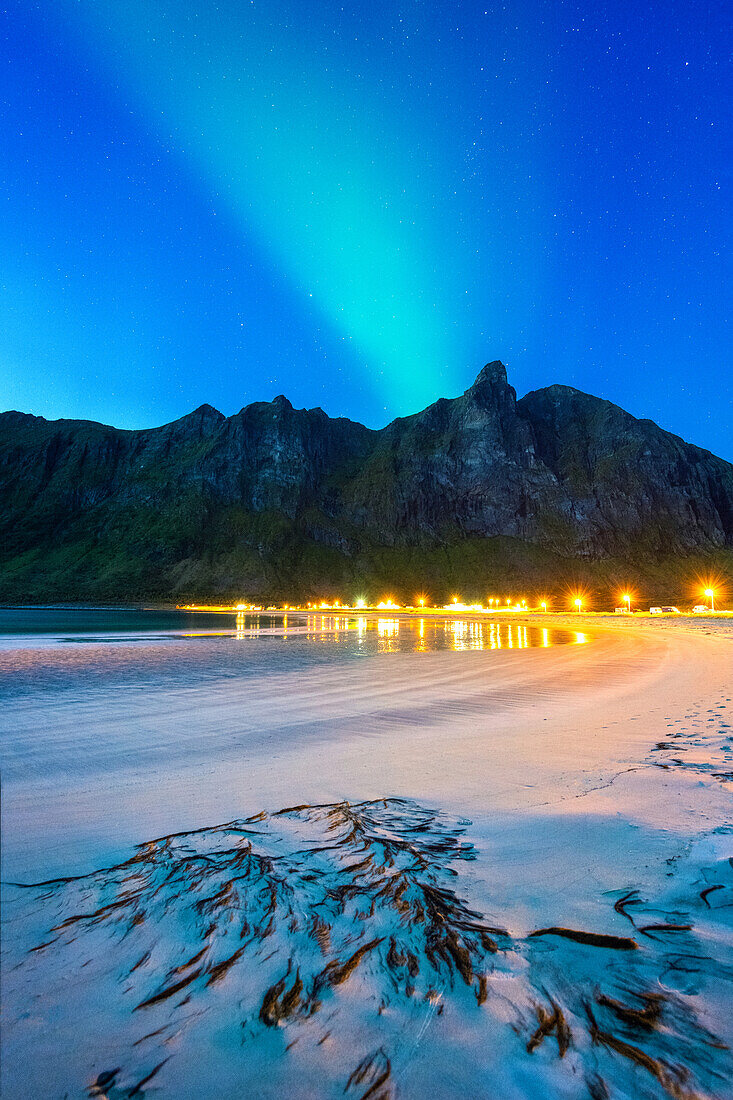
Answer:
8 799 510 1098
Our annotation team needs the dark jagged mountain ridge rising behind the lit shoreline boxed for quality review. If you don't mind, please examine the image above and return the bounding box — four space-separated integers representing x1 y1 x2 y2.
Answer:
0 362 733 601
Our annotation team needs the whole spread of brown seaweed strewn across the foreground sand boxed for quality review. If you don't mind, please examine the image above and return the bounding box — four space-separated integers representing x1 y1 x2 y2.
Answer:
5 799 731 1100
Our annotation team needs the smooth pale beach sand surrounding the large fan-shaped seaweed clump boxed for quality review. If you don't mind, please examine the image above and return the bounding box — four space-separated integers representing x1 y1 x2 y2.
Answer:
3 615 733 1098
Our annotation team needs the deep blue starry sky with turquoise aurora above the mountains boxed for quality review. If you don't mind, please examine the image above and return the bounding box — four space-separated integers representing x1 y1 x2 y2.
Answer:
0 0 733 460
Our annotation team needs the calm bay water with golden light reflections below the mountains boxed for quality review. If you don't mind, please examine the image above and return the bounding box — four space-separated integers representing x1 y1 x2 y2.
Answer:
0 611 588 704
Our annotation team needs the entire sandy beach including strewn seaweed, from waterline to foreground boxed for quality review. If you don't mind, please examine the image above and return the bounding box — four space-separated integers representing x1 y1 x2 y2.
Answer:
0 615 733 1098
